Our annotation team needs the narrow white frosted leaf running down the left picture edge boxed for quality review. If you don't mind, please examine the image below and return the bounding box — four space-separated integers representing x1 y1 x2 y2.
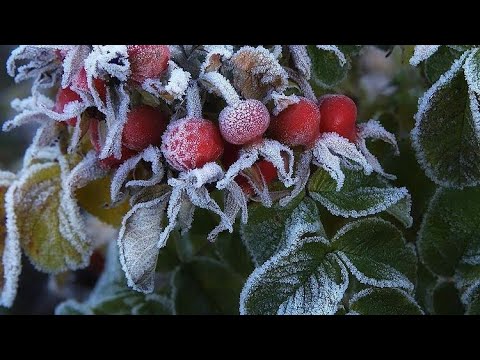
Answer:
0 171 21 307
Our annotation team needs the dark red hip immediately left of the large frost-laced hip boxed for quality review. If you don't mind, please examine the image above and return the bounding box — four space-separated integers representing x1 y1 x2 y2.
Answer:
122 105 168 151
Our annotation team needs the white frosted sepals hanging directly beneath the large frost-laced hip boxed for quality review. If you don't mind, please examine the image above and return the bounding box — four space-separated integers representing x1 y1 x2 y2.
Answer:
158 162 233 248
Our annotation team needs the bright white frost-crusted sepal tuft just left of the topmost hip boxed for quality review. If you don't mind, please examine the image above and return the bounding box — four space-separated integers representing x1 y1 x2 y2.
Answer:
85 45 130 81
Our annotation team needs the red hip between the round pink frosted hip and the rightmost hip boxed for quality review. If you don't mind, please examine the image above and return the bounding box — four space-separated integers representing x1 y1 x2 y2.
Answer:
269 98 320 146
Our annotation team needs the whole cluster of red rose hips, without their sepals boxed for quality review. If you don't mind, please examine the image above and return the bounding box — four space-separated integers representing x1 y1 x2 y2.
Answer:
54 45 357 195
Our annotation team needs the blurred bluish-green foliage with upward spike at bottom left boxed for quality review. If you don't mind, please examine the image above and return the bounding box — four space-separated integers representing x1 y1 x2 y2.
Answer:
55 241 173 315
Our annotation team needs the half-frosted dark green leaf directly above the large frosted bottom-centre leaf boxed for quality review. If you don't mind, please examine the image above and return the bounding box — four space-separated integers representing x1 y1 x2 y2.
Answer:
241 193 325 266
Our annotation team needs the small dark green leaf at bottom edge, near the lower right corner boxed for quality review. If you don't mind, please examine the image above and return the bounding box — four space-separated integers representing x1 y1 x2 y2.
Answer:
432 281 464 315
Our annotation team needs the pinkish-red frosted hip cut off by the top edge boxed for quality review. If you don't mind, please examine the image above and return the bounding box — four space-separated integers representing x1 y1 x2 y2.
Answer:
127 45 170 84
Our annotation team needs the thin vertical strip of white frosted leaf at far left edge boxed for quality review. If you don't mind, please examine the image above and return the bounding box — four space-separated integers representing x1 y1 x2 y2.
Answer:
0 179 22 307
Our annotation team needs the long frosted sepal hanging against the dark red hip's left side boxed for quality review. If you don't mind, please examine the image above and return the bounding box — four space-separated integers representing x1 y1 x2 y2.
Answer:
99 84 130 159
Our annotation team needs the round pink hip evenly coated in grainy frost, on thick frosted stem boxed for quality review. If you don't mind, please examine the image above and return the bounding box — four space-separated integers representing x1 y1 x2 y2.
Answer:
218 99 270 145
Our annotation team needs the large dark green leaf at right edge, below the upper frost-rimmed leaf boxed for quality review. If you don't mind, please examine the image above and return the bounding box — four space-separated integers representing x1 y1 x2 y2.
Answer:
417 188 480 277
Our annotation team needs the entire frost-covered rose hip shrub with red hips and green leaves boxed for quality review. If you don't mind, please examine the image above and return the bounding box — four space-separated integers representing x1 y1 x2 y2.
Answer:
0 45 480 315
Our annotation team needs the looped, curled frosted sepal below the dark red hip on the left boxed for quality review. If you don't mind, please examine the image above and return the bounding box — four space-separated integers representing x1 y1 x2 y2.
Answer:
110 145 165 202
